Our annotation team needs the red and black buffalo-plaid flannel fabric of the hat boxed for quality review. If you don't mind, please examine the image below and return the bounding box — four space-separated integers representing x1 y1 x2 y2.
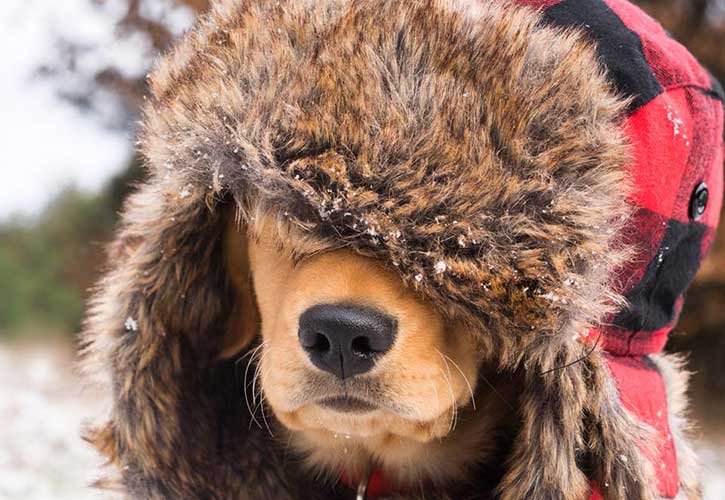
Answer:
518 0 723 499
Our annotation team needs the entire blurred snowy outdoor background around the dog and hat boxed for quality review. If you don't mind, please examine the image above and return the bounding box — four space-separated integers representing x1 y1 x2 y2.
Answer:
0 0 725 500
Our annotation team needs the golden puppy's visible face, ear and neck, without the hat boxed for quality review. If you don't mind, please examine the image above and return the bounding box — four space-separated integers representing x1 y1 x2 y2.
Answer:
223 213 521 491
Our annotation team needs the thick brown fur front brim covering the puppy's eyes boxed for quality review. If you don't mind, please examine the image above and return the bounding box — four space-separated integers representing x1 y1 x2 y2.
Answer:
143 1 628 356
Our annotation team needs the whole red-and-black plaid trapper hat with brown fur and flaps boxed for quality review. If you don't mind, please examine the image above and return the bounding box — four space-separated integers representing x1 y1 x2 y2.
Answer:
85 0 723 499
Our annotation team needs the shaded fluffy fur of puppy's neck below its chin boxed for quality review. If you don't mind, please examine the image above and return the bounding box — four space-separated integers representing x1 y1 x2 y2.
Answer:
288 376 516 496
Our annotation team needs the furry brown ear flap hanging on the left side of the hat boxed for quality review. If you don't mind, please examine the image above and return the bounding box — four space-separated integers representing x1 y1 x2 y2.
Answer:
82 182 252 492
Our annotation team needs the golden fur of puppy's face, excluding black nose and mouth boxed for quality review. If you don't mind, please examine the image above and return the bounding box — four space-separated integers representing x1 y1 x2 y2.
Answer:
228 217 492 482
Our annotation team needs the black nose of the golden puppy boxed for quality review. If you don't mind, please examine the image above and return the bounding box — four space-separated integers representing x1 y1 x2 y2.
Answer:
299 304 398 379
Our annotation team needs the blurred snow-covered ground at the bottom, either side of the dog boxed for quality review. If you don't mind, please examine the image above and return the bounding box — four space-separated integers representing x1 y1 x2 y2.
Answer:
0 343 725 500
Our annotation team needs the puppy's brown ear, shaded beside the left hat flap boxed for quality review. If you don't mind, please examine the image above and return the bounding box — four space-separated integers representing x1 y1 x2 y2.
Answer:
219 215 259 359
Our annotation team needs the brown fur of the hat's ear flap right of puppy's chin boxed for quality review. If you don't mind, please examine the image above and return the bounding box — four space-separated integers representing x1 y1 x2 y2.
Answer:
498 341 659 500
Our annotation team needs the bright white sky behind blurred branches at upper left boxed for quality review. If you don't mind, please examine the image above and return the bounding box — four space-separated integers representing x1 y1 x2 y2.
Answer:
0 0 190 222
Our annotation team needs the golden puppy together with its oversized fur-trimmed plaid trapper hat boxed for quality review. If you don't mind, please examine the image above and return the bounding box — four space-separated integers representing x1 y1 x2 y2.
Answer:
82 0 723 500
